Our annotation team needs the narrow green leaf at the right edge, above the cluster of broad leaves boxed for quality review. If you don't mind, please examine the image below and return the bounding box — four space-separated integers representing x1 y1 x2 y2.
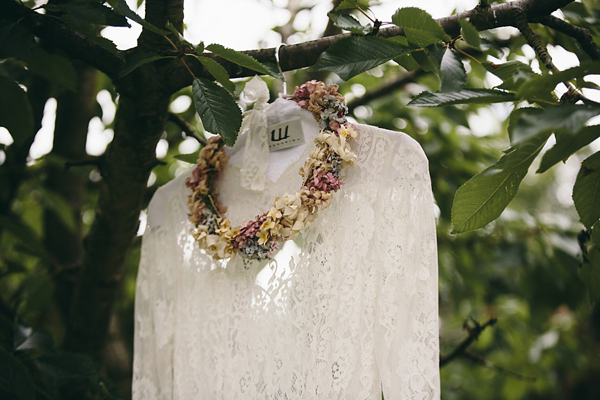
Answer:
518 61 600 99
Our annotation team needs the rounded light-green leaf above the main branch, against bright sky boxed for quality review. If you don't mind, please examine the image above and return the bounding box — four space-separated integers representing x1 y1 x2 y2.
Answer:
392 7 450 47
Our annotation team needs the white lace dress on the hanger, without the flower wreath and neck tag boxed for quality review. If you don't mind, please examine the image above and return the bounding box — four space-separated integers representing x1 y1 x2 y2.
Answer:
133 102 440 400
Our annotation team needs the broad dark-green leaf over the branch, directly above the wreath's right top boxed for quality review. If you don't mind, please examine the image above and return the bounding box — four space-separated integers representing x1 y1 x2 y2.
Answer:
313 36 410 80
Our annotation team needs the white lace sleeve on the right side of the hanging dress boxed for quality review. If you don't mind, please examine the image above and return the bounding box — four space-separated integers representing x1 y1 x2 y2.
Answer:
373 133 440 400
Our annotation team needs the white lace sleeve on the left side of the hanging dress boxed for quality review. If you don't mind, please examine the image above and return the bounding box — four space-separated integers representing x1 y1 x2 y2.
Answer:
132 192 177 400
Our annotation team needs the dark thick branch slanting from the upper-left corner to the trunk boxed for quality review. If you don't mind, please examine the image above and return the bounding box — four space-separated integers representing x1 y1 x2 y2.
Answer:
0 0 123 78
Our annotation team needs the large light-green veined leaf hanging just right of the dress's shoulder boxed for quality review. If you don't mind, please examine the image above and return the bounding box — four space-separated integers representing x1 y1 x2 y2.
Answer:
452 133 550 233
